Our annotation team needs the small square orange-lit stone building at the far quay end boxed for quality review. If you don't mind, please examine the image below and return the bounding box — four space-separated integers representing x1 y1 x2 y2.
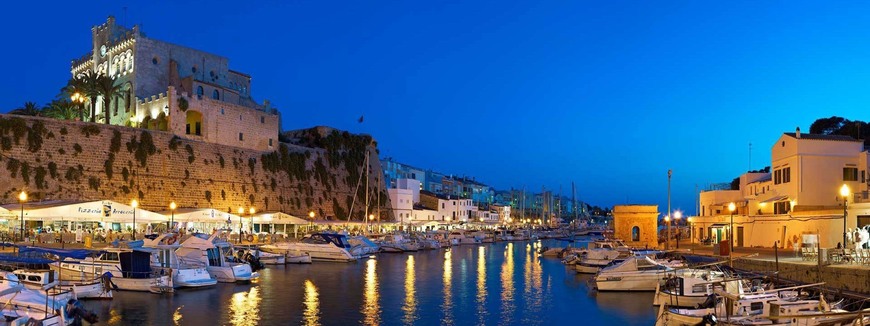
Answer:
613 205 659 248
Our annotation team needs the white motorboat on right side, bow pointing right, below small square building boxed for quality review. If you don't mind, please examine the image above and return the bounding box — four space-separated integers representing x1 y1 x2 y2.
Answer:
595 256 695 291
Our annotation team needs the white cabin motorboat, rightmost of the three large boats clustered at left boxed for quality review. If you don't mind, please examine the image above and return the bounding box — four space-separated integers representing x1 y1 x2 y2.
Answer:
175 232 260 283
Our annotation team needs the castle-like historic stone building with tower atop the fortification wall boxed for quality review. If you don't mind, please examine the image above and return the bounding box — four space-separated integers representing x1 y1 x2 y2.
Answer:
71 16 281 151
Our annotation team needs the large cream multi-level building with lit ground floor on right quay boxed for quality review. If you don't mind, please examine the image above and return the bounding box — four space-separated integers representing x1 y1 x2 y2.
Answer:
689 129 870 248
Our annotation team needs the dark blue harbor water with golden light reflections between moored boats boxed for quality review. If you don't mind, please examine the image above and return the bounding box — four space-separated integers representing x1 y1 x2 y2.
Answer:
84 240 656 325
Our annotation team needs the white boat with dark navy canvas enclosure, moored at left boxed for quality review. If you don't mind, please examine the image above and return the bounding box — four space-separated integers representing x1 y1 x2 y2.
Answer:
51 248 174 293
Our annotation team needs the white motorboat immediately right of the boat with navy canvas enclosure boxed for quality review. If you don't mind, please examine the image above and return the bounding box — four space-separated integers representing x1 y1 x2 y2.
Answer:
142 234 217 288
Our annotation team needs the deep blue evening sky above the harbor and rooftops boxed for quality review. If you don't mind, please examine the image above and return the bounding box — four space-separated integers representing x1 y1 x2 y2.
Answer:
0 0 870 214
